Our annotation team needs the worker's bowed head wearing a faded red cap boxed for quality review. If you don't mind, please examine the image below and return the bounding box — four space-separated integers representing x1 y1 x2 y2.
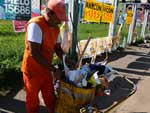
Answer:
46 0 68 26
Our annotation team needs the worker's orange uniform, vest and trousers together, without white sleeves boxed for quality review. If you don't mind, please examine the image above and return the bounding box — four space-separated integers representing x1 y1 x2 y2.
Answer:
21 16 59 113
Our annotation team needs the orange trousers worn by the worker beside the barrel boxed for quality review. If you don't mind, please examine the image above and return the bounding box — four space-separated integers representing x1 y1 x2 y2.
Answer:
23 73 55 113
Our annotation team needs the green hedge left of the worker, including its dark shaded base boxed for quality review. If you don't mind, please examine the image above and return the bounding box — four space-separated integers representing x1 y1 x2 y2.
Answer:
0 32 24 95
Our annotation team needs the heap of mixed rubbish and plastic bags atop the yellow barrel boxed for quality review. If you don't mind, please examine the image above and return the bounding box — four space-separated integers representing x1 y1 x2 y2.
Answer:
55 55 114 95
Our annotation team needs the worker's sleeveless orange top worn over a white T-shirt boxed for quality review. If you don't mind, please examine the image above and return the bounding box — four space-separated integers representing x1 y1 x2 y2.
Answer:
21 16 59 75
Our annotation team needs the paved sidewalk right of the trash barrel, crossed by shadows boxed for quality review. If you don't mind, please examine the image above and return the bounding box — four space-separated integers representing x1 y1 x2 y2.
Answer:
106 44 150 113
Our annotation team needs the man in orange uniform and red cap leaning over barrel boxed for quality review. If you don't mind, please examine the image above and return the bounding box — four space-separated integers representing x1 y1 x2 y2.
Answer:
21 0 68 113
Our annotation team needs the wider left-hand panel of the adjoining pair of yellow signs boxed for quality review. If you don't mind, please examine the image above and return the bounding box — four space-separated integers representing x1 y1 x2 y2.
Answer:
83 1 102 22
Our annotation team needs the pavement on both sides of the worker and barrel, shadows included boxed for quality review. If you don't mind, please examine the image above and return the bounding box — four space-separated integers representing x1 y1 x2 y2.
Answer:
0 44 150 113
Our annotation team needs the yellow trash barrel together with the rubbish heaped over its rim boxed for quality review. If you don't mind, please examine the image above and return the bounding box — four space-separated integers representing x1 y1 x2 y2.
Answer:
55 56 132 113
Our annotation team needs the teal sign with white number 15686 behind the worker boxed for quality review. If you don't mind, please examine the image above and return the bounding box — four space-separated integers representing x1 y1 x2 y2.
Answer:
0 0 31 20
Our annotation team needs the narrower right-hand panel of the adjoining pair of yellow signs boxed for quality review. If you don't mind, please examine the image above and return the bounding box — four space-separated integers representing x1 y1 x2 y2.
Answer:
101 4 114 23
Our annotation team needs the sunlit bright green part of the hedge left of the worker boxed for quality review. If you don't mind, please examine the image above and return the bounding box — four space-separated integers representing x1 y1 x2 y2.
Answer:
0 34 24 72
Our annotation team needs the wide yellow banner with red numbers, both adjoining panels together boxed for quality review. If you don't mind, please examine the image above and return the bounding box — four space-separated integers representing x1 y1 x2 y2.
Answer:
83 0 114 23
